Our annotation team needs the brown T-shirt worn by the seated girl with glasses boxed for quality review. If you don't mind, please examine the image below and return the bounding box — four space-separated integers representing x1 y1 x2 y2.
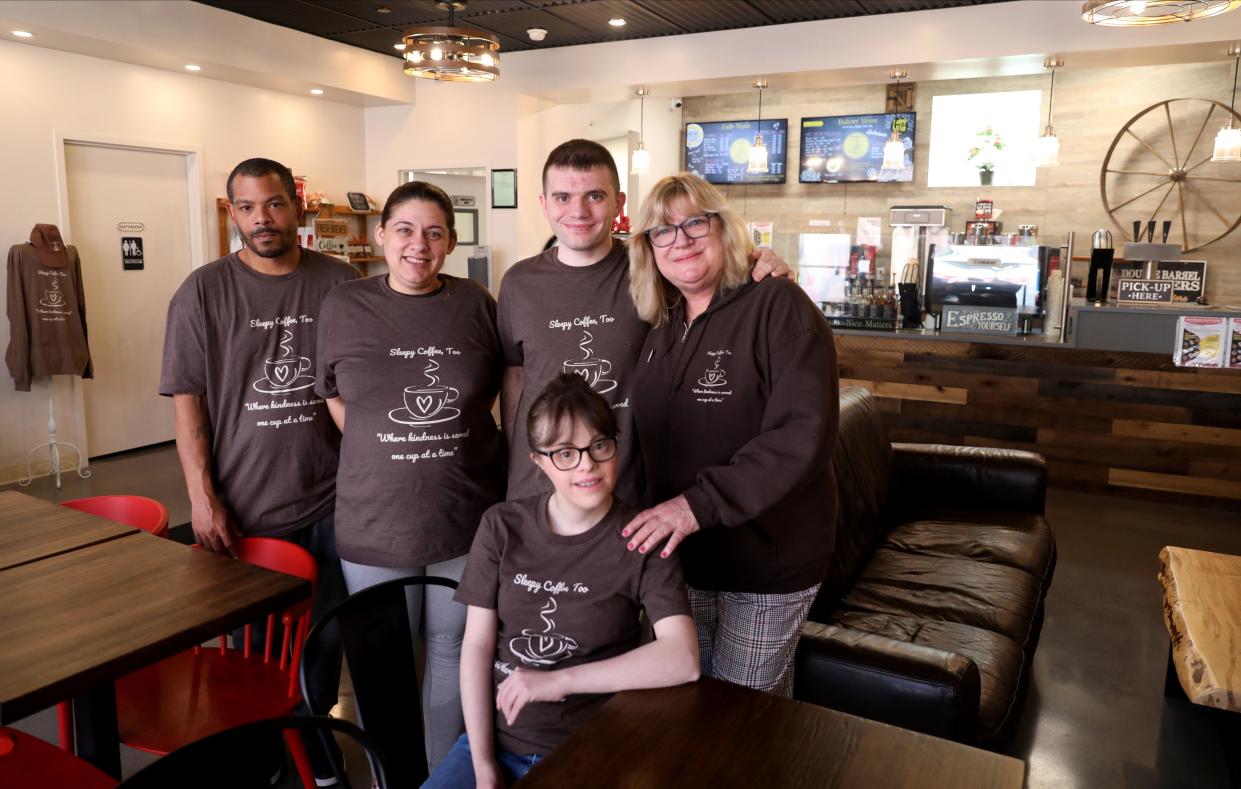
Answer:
454 495 690 754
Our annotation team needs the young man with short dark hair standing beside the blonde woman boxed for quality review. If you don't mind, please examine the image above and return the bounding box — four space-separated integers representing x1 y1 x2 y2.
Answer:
496 140 789 505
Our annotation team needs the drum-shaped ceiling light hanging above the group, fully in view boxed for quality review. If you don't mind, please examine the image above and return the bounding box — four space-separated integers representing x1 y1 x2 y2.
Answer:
402 0 500 82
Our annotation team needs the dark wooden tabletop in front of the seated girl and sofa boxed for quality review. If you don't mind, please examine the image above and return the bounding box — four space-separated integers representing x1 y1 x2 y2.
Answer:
517 679 1025 789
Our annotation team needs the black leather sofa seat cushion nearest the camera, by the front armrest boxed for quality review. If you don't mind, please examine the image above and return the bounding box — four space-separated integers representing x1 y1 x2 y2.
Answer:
833 612 1025 741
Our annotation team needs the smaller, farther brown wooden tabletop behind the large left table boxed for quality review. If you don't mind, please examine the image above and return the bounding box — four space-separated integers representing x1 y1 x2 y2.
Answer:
0 490 138 571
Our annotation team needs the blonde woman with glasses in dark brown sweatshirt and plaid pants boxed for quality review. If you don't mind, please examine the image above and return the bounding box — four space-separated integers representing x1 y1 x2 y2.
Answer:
622 174 839 696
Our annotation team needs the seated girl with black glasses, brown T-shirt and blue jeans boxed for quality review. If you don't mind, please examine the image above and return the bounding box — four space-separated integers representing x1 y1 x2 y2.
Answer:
424 373 699 788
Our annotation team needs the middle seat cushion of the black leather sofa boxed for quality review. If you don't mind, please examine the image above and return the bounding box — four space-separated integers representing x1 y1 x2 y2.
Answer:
829 547 1042 649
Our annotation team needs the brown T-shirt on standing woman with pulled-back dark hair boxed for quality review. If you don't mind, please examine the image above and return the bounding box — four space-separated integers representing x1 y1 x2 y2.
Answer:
315 275 504 567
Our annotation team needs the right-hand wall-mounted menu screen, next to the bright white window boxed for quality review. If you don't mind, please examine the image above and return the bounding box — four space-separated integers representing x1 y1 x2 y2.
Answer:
797 113 917 184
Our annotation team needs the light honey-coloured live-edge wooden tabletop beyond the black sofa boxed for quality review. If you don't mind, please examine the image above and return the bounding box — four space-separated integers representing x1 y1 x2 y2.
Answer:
1159 546 1241 712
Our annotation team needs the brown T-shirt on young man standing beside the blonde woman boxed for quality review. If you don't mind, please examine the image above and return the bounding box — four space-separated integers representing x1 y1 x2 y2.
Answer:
499 242 648 504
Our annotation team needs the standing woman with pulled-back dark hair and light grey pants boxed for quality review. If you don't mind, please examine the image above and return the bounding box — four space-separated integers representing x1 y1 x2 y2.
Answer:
316 181 505 764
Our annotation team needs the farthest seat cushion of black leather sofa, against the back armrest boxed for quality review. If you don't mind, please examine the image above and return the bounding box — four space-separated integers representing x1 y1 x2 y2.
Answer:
885 512 1055 583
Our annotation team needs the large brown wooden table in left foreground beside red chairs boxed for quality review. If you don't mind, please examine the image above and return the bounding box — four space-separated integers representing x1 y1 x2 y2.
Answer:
0 494 310 778
